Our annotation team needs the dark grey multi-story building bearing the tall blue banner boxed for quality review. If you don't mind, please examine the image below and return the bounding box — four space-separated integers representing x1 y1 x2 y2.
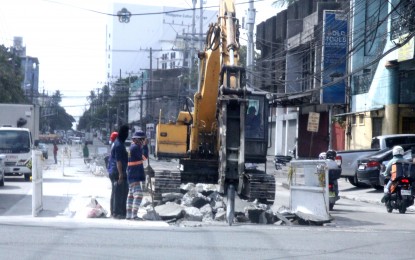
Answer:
256 0 349 157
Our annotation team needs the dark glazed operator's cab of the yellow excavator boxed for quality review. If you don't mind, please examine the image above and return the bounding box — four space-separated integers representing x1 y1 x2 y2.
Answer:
245 93 269 163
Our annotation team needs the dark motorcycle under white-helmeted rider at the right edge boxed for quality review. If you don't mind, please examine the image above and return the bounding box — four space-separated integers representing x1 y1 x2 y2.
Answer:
385 162 415 214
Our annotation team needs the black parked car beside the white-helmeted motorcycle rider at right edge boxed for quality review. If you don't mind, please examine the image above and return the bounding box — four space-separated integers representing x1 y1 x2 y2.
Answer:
356 144 415 190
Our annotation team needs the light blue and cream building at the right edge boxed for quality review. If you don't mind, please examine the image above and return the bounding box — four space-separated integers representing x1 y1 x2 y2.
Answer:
339 0 415 149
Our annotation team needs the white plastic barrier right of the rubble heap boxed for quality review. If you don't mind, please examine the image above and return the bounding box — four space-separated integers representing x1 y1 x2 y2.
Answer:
290 160 331 221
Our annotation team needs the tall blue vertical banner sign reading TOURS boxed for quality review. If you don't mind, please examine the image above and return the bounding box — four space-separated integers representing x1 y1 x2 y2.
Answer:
320 10 347 104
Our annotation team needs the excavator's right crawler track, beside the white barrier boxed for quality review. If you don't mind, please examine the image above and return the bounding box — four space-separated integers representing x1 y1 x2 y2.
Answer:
241 171 275 203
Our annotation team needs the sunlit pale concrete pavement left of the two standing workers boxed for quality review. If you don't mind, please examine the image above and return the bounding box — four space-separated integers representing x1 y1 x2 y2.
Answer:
0 147 169 228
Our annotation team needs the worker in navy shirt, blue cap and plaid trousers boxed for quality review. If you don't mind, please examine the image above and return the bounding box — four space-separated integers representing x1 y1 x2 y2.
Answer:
126 130 148 220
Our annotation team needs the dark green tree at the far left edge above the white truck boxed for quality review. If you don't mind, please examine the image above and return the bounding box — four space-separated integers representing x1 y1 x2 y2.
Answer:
0 45 26 103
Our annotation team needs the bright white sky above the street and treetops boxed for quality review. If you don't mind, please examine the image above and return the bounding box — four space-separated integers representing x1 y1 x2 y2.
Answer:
0 0 277 119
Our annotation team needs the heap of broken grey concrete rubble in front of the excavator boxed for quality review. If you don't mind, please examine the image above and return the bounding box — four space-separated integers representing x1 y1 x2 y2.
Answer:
142 183 332 225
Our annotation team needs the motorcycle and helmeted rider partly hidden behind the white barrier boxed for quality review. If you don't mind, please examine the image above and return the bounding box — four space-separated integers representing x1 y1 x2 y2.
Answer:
319 150 342 210
